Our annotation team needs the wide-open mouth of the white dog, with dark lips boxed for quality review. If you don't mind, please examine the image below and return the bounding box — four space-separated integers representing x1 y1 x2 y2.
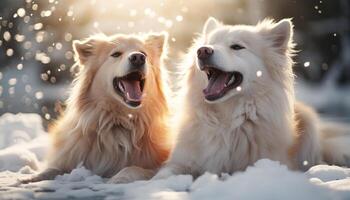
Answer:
203 67 243 101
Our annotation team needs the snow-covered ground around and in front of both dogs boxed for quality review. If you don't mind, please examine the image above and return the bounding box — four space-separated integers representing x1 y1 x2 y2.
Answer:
0 114 350 200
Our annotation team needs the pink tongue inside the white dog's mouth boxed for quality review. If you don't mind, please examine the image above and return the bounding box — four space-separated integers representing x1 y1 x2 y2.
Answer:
203 73 230 96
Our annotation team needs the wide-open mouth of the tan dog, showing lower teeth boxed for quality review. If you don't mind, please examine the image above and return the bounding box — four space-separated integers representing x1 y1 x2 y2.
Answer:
113 71 146 107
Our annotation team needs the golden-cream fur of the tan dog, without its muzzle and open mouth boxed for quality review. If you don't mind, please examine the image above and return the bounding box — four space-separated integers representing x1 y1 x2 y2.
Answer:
23 34 170 183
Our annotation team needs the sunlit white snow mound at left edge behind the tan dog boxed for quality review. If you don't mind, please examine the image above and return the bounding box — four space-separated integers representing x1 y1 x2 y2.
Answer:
0 113 48 173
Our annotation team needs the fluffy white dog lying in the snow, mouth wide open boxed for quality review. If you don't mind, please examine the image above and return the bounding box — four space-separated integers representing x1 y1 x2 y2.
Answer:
154 18 350 179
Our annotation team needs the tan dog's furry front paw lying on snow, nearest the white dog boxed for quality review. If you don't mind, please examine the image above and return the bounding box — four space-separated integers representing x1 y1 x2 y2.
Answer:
108 166 155 183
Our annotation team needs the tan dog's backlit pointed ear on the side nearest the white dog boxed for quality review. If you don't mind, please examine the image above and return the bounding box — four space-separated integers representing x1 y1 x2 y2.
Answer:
145 31 168 57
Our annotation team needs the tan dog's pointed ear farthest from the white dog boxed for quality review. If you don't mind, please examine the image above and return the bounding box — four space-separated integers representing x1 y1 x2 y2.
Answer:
73 39 94 64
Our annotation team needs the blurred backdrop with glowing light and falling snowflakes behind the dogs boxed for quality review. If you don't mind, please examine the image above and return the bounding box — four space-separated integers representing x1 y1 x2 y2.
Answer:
0 0 350 124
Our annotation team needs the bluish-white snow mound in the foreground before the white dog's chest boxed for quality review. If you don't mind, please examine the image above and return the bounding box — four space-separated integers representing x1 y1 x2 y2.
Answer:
192 159 332 200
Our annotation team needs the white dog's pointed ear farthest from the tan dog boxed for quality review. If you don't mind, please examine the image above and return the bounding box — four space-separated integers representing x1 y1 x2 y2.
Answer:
263 19 293 54
